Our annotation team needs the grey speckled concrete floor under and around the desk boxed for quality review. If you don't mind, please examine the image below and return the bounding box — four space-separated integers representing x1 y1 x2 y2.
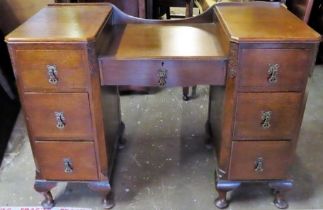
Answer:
0 66 323 210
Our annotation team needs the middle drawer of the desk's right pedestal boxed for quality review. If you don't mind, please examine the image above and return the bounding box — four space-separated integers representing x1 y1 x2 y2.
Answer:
233 93 302 140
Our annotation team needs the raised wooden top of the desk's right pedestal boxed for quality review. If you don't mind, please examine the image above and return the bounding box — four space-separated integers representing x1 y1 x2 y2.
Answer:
215 2 320 42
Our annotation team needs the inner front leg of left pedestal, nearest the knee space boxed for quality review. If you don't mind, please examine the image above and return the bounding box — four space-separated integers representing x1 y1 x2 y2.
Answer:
88 181 115 209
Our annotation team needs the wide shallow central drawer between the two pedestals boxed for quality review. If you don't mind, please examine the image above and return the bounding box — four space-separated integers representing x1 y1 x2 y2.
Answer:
99 57 226 87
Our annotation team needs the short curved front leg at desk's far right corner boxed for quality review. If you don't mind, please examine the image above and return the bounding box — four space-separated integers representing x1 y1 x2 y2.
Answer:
269 180 293 209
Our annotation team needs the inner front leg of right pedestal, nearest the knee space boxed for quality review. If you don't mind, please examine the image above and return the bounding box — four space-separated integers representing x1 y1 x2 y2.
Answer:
214 180 240 209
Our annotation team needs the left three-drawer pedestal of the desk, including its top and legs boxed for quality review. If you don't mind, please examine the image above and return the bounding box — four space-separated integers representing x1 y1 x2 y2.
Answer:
8 4 124 208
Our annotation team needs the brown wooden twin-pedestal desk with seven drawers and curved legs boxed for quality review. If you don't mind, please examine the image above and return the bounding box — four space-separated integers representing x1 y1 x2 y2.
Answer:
6 2 320 208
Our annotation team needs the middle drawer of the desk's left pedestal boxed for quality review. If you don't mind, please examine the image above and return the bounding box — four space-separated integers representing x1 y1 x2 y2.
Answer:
23 93 92 140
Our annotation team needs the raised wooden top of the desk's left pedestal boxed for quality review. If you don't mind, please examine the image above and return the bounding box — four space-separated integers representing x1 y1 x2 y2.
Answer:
6 4 112 42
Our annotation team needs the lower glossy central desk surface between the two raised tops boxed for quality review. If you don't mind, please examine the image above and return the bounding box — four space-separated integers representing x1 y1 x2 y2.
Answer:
115 23 227 59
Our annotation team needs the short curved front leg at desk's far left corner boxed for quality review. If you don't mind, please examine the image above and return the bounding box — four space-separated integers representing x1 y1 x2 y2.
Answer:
34 180 56 209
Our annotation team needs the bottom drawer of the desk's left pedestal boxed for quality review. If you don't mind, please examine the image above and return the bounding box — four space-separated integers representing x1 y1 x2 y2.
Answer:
33 141 98 180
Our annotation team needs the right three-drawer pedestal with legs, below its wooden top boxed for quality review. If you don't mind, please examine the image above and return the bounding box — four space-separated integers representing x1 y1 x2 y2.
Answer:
207 40 315 208
